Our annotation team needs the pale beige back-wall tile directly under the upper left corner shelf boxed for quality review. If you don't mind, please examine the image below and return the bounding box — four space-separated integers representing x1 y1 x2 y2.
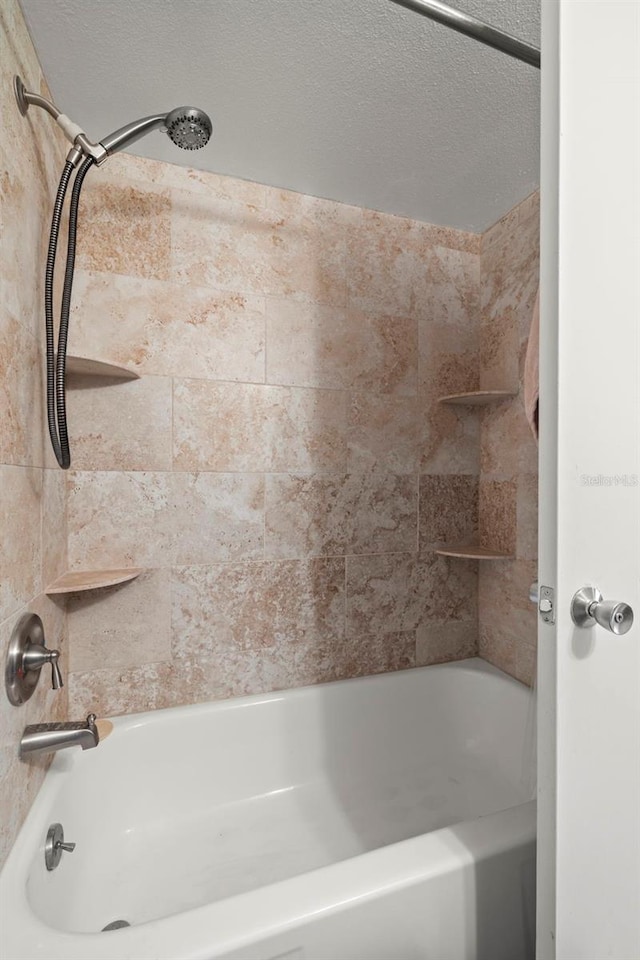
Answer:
67 375 173 470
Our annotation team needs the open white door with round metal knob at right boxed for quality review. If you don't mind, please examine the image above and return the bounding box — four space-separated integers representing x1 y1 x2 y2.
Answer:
537 0 640 960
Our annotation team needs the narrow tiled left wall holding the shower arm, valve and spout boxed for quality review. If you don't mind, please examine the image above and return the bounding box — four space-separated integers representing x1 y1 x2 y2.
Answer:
0 0 67 865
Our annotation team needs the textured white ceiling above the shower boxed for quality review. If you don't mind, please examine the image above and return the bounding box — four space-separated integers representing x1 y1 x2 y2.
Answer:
21 0 540 231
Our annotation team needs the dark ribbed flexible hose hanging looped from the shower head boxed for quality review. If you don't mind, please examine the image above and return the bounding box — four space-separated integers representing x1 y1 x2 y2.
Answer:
44 157 94 470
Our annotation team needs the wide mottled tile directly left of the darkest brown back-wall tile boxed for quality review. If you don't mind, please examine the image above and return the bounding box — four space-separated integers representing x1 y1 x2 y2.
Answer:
265 473 417 559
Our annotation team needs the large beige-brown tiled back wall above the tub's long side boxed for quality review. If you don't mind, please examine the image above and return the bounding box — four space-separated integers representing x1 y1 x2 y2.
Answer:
68 156 480 714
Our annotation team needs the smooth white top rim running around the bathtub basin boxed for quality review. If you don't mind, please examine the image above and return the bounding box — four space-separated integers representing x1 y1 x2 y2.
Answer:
0 657 536 960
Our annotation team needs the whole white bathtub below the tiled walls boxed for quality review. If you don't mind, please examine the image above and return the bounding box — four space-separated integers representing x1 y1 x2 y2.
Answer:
0 660 535 960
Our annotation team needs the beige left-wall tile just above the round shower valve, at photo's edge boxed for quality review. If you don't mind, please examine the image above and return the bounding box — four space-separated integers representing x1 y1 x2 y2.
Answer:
0 466 42 622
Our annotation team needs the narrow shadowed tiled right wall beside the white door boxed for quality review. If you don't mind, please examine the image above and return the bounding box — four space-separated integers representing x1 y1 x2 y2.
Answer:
478 194 539 683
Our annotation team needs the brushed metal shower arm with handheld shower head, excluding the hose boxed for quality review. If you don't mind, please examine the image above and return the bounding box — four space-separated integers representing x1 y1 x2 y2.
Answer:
13 76 213 167
